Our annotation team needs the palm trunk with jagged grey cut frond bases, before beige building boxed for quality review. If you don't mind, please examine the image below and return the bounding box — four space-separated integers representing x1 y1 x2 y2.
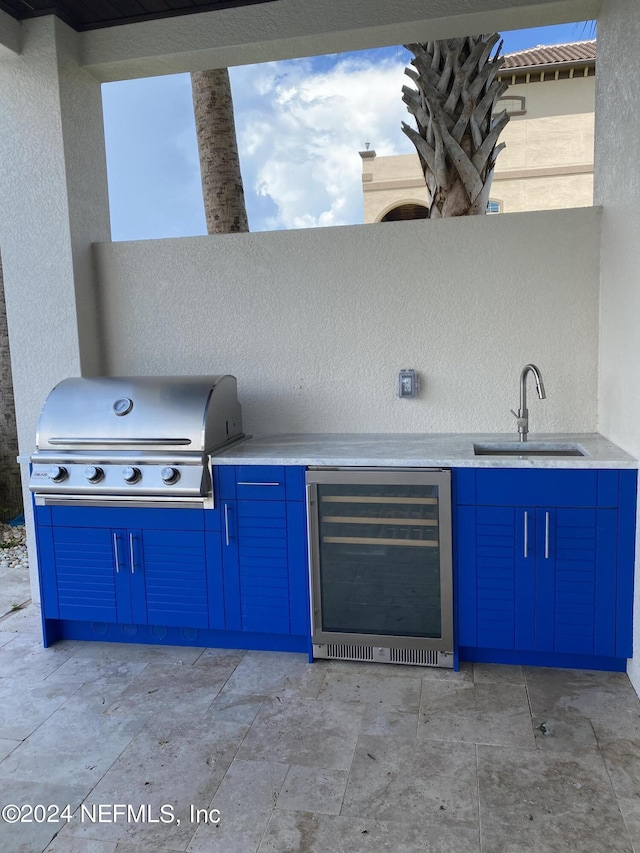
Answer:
402 33 509 219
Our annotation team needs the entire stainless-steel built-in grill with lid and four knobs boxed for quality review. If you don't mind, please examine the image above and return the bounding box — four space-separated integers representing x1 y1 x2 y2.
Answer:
29 375 244 507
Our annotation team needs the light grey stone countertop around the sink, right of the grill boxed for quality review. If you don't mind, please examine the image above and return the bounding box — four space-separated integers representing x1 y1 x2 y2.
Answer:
213 432 638 469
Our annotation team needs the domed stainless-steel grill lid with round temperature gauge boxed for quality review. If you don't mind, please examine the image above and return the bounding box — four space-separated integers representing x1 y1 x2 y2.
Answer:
36 375 242 453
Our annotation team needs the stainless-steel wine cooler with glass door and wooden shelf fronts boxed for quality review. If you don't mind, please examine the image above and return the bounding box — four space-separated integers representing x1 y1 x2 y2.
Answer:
307 468 454 668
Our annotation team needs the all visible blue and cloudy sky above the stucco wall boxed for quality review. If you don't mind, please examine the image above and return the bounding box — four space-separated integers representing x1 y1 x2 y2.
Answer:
102 23 593 240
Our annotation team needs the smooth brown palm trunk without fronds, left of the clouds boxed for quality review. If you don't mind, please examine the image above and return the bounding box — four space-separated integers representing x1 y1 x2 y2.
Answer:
191 68 249 234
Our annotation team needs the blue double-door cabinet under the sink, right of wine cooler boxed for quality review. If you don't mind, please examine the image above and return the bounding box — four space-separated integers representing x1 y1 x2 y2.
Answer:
455 469 636 669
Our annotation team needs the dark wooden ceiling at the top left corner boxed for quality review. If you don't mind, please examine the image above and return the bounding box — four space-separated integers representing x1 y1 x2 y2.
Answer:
0 0 277 32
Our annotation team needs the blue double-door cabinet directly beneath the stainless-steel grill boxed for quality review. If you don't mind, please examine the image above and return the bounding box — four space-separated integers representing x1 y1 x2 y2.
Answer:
36 507 214 644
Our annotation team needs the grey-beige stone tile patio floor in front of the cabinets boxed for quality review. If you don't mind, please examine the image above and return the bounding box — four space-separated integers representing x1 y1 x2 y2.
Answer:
0 584 640 853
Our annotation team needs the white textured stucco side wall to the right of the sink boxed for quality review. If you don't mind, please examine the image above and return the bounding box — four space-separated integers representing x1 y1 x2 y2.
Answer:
595 0 640 693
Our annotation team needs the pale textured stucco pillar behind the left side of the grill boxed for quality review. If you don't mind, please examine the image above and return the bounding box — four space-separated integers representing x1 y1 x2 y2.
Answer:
0 17 109 600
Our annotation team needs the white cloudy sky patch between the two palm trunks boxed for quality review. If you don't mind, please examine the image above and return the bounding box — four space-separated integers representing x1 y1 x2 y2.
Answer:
231 51 412 230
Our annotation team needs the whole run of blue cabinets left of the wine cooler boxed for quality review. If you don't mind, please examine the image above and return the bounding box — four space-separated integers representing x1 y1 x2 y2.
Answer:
35 466 310 651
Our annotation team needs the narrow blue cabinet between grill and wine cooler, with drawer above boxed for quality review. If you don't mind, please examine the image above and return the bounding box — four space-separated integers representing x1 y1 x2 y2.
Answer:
216 465 310 648
